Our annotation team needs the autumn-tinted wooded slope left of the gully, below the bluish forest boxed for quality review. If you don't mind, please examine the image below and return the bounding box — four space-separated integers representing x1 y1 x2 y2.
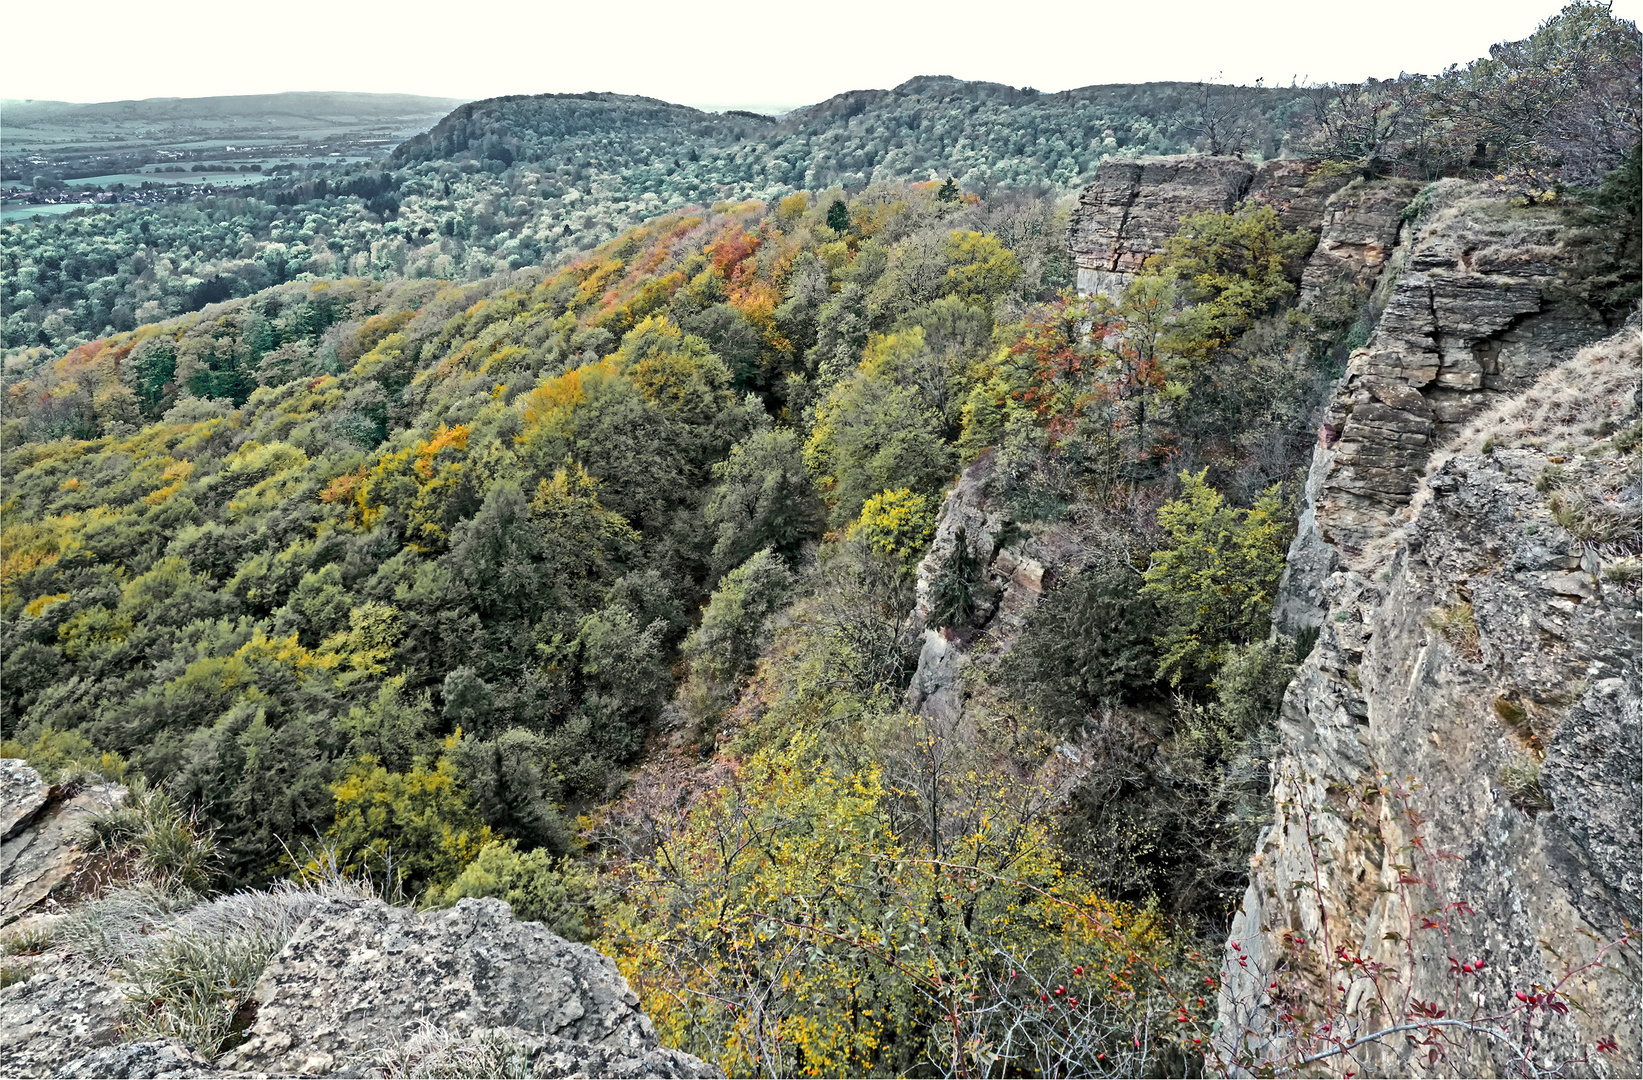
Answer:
5 180 1066 881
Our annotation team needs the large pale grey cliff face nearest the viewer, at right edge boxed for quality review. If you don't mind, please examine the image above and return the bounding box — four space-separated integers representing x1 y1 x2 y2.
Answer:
1221 328 1643 1077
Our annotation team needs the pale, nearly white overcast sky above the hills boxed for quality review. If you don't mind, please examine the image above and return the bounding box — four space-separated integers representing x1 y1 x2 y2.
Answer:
0 0 1643 110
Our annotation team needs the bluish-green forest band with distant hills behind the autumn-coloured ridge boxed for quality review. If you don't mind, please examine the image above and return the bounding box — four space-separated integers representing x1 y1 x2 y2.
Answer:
0 79 1301 364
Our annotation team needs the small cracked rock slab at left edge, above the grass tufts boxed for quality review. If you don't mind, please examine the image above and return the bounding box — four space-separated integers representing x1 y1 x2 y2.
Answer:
0 758 125 925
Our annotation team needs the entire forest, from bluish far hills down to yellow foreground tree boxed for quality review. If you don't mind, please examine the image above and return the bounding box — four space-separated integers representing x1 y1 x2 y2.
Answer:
0 3 1640 1075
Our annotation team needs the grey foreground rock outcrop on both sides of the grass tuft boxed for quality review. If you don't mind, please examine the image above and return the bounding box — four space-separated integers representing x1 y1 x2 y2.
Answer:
0 894 720 1077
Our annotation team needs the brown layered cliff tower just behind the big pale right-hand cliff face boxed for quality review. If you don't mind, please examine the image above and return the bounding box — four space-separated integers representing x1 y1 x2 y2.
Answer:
1308 182 1607 557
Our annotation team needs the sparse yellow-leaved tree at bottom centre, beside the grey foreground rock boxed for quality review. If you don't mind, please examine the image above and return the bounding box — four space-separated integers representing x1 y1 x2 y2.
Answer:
600 733 1204 1075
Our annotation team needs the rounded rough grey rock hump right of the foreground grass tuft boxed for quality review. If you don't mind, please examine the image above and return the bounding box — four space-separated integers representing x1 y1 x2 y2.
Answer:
219 899 715 1077
